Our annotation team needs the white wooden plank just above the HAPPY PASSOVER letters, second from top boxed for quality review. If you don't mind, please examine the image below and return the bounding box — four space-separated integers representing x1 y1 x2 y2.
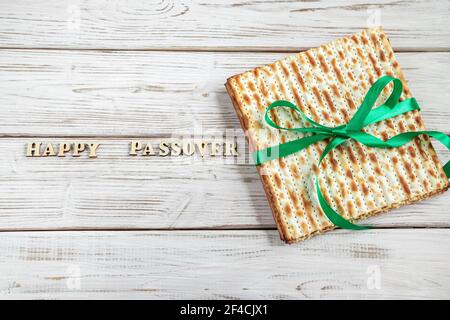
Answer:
0 50 450 136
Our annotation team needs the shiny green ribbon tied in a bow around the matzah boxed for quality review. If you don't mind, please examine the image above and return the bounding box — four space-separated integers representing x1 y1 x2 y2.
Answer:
253 76 450 230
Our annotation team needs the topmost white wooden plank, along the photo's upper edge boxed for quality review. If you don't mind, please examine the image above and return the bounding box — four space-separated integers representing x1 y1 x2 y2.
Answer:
0 0 450 50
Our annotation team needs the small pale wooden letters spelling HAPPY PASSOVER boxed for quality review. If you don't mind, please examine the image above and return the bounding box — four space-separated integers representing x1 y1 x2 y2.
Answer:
26 140 238 158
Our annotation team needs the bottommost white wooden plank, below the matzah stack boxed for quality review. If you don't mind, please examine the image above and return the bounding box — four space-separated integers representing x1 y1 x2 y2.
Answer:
0 229 450 299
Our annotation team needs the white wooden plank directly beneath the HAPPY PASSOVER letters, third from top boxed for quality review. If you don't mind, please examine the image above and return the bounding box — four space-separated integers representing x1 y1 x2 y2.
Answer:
0 138 450 230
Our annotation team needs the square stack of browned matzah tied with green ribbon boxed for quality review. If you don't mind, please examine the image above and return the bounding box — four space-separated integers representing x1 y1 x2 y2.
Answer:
226 28 449 243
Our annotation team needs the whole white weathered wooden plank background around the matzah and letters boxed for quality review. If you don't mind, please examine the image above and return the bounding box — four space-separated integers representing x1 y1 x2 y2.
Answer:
0 0 450 299
